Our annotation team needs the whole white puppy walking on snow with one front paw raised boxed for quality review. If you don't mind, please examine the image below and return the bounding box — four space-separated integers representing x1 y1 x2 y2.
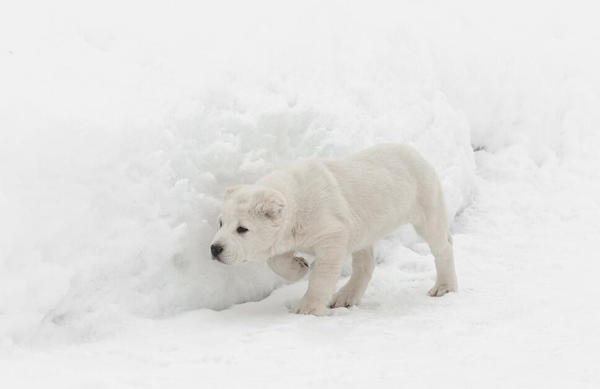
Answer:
211 144 458 315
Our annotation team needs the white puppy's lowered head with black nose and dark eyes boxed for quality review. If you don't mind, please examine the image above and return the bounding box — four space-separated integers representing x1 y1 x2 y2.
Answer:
210 185 286 265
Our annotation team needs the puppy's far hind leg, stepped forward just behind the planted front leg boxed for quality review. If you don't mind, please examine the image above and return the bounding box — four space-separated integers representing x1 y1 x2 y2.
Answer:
330 246 375 308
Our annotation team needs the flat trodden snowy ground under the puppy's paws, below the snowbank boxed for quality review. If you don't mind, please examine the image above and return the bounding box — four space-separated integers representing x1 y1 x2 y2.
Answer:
1 148 600 388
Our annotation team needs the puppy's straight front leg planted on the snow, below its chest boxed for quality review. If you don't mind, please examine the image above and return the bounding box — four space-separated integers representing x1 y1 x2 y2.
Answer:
292 249 347 316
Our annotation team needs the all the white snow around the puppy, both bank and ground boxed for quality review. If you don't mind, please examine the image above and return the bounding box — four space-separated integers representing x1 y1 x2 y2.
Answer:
0 1 600 388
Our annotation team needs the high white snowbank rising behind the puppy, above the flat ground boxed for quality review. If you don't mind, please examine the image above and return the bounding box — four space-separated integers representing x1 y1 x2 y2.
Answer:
0 2 600 341
